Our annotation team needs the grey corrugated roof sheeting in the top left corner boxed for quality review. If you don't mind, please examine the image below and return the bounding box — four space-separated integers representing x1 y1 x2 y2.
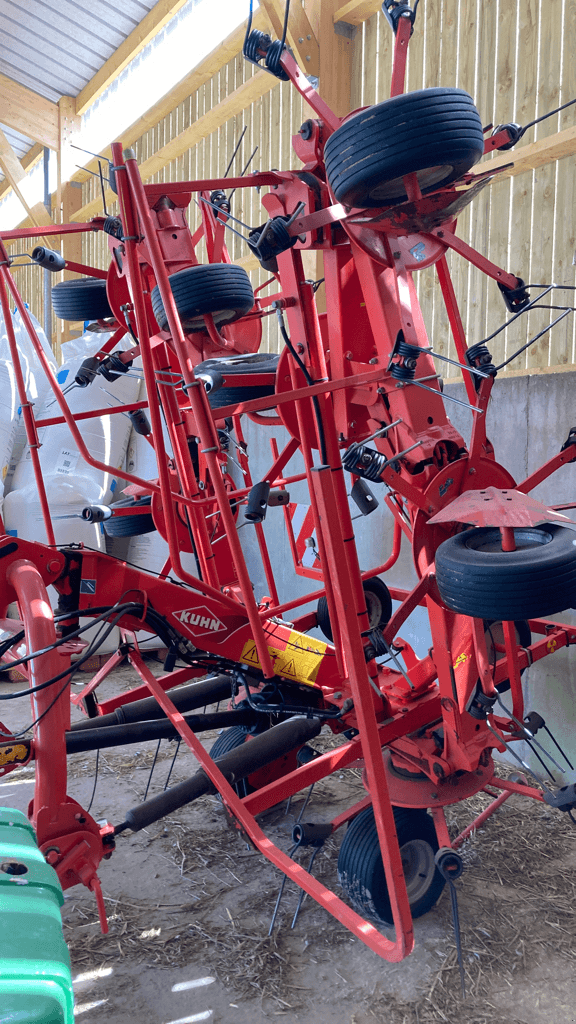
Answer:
0 0 161 177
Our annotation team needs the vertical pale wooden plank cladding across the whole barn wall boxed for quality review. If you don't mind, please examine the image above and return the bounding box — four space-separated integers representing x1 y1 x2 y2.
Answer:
8 0 576 377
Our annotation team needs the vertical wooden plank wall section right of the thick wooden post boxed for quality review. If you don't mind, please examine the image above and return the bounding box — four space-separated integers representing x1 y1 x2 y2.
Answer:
353 0 576 377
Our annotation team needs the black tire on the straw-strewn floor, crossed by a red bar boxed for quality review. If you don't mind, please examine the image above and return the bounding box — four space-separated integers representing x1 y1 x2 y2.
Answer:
338 807 445 925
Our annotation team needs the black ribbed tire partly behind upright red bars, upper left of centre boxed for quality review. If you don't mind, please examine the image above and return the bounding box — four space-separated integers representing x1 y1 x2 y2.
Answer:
151 263 254 332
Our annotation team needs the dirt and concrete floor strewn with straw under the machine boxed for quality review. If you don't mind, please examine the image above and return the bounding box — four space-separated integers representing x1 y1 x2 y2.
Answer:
0 663 576 1024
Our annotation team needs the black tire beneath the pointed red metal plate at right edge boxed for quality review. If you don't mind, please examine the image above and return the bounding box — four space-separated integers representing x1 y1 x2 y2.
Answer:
436 523 576 621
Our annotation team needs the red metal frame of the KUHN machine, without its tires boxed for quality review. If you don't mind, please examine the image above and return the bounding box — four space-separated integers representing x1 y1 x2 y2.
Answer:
0 18 576 961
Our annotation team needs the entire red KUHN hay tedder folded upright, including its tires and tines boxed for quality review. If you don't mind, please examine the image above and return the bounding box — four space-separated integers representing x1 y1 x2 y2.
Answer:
0 0 576 961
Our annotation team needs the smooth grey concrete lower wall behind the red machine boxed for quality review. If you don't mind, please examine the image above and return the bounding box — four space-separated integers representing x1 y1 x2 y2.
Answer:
240 373 576 782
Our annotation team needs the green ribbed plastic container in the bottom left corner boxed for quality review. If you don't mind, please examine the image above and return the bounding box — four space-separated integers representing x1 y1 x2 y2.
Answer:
0 808 74 1024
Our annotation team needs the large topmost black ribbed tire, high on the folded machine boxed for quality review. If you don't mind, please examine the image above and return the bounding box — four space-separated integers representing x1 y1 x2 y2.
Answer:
324 88 484 207
